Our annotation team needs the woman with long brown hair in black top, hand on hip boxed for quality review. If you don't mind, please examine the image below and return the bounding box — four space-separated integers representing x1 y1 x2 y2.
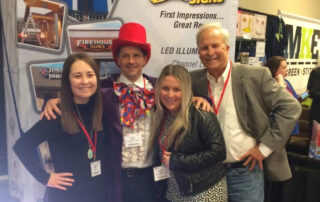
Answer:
13 53 112 202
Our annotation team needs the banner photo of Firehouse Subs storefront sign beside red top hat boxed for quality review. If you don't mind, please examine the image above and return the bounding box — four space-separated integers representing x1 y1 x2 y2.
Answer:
67 20 122 79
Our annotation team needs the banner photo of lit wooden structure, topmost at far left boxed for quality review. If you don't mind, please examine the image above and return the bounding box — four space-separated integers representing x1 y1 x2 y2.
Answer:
16 0 67 52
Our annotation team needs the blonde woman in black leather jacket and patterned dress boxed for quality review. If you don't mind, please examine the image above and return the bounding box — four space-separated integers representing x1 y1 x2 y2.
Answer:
151 65 227 202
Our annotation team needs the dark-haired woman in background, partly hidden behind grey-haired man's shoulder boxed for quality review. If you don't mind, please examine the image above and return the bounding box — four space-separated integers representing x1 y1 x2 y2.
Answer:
265 56 299 135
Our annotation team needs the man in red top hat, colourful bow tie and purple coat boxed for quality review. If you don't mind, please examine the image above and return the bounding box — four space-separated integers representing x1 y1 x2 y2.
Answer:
43 22 210 202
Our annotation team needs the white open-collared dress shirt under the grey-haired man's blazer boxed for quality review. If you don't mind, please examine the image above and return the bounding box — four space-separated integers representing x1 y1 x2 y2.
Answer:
207 61 272 163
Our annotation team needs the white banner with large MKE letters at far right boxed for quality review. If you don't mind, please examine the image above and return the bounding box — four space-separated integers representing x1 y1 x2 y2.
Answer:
281 12 320 94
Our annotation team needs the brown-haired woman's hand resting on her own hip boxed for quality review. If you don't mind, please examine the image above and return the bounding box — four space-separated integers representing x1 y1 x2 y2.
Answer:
47 173 74 191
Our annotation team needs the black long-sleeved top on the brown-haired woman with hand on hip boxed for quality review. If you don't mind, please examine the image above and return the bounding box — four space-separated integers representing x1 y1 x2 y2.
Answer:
13 105 108 202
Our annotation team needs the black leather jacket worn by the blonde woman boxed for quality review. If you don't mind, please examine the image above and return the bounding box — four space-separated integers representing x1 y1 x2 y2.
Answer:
156 105 226 196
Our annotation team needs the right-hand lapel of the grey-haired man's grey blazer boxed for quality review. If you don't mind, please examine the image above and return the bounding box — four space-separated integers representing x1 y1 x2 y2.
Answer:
231 63 248 130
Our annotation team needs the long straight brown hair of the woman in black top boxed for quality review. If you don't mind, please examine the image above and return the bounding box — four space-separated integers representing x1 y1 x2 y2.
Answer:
60 53 102 134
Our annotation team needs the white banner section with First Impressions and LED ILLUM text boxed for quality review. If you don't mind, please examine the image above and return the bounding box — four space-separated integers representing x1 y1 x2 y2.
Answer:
109 0 238 76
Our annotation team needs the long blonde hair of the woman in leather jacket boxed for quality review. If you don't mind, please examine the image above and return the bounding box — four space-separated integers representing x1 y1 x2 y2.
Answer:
150 65 193 149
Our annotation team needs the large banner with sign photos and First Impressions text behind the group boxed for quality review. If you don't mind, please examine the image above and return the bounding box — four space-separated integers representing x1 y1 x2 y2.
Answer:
1 0 238 202
